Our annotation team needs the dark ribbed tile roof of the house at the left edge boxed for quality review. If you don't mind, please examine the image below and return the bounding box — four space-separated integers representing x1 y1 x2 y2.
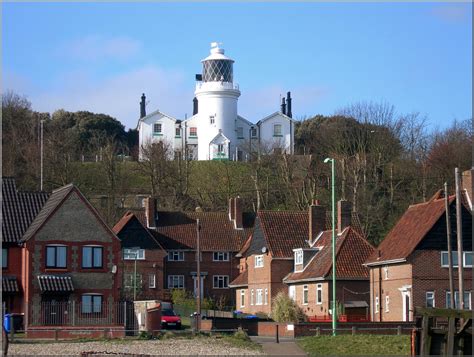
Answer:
2 177 49 243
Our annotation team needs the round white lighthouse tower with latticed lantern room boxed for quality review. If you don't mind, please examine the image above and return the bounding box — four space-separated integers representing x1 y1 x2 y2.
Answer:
194 42 241 160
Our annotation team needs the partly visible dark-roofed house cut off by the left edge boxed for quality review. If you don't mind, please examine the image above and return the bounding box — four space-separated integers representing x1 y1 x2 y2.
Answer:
2 177 49 313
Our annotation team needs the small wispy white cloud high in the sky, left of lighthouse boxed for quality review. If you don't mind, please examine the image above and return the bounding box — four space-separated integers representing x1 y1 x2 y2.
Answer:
59 35 142 61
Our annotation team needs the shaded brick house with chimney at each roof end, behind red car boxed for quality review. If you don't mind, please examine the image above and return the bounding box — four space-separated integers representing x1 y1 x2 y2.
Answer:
115 197 254 306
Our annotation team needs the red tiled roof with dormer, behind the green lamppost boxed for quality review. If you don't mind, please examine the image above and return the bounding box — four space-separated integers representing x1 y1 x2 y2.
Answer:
284 227 375 283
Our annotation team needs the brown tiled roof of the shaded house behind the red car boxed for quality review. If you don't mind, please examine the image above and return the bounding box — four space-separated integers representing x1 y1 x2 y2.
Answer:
133 210 255 252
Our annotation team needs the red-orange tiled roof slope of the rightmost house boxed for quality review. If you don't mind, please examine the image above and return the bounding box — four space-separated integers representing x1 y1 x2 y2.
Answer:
366 191 455 265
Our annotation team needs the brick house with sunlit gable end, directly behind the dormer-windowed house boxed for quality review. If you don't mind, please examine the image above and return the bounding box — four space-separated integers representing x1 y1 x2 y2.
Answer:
230 200 364 314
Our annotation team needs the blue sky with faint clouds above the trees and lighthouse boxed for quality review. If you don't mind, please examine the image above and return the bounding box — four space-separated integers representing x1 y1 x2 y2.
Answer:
1 2 472 129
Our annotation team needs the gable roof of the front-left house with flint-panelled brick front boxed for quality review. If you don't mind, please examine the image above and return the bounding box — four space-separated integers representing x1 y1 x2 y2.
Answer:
21 184 118 242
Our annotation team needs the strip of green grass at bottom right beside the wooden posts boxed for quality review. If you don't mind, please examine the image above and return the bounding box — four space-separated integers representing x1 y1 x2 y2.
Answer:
297 335 410 356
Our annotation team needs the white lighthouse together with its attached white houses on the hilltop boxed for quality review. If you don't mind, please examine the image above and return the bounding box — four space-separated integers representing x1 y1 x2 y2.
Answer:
138 42 294 161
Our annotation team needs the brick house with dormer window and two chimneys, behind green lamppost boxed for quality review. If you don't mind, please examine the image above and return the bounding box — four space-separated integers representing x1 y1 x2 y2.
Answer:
283 201 374 320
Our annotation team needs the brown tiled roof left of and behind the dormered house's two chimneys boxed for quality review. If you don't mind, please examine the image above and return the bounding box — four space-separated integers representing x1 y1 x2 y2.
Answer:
257 211 362 258
